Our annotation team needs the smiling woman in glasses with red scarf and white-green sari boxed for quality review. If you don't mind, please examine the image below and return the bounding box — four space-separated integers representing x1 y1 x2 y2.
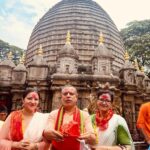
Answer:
91 84 134 150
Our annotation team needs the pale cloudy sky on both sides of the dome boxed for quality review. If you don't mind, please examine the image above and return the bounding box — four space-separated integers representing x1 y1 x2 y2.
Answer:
0 0 150 49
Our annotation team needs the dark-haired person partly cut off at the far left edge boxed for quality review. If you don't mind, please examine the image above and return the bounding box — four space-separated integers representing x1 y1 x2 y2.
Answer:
0 105 8 129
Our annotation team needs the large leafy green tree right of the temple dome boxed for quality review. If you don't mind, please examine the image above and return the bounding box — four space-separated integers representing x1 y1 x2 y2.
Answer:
121 20 150 76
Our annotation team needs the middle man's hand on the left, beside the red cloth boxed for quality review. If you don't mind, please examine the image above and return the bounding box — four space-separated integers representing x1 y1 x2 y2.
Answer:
43 129 63 141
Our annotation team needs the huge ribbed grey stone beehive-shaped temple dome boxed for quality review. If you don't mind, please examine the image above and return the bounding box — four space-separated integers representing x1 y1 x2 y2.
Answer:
26 0 124 70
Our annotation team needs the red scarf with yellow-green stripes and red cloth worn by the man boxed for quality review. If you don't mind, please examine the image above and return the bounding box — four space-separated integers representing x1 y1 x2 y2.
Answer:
52 107 83 150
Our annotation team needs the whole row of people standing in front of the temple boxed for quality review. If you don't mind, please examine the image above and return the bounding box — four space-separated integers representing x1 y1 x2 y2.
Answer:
0 85 150 150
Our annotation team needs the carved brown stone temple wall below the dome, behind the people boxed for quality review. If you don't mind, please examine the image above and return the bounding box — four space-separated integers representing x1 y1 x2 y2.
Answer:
0 53 150 143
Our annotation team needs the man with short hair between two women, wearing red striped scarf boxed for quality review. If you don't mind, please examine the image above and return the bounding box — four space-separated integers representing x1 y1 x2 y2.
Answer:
43 85 95 150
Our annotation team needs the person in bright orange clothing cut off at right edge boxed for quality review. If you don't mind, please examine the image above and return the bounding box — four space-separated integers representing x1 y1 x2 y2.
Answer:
137 102 150 150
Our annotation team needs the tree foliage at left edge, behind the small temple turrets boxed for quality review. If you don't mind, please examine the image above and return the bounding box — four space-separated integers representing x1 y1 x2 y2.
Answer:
0 40 24 64
